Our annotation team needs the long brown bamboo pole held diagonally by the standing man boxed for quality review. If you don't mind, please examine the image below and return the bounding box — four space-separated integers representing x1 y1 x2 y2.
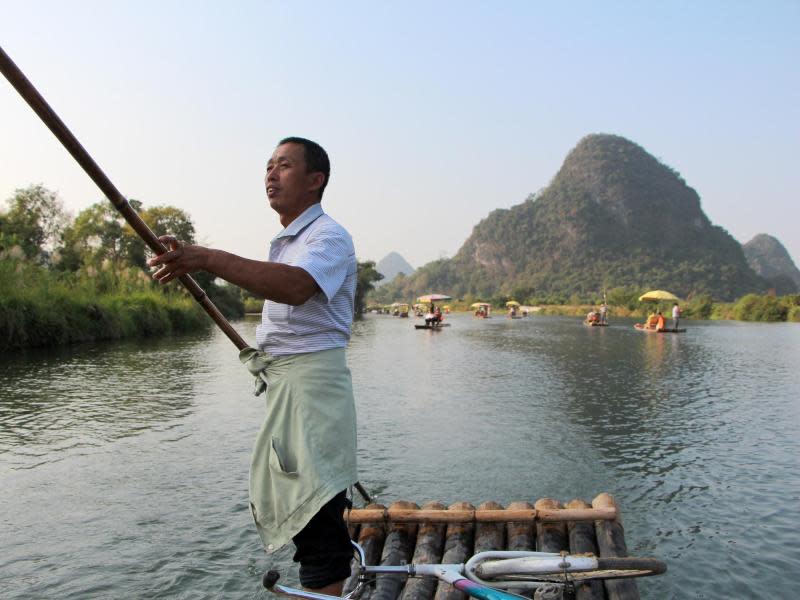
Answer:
0 47 247 350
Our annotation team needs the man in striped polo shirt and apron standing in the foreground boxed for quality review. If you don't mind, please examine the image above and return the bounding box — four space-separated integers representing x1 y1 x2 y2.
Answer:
150 137 357 596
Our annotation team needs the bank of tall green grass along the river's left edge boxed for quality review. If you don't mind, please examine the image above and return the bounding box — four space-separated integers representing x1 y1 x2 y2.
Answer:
0 261 210 351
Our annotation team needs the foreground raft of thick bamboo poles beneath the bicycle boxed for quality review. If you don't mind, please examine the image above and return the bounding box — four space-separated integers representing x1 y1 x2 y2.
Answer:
344 493 639 600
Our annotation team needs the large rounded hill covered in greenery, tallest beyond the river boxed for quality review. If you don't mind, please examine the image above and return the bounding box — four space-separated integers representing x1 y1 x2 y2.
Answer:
372 134 767 300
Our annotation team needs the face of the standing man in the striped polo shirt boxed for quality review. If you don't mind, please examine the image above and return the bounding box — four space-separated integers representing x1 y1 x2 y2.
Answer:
264 143 324 216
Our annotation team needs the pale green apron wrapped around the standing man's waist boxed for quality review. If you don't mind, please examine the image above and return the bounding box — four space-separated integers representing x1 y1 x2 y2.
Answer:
239 348 358 552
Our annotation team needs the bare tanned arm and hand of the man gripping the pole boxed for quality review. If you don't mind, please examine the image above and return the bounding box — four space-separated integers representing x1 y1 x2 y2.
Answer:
148 235 320 306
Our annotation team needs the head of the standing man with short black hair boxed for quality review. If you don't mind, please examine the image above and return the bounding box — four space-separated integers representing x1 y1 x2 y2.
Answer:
264 137 331 222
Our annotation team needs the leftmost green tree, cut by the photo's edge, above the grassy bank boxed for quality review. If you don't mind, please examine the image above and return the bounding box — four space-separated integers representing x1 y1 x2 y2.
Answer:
0 184 67 262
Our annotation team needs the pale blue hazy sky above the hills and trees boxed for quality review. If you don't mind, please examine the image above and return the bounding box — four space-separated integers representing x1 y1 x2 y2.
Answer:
0 0 800 267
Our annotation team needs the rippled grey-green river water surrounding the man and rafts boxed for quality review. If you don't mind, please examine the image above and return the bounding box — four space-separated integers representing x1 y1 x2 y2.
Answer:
0 315 800 599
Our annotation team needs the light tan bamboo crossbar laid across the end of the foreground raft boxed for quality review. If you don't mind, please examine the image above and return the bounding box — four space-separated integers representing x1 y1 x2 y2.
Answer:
345 506 617 523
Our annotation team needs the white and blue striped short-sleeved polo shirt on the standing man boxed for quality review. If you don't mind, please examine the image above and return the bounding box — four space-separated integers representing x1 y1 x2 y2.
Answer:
256 203 356 356
